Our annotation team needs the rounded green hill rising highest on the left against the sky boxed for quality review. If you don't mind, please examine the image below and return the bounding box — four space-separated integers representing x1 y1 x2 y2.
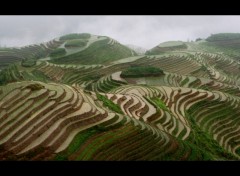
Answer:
51 34 137 65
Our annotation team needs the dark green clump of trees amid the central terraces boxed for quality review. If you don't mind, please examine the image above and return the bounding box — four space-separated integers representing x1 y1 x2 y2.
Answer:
120 66 164 78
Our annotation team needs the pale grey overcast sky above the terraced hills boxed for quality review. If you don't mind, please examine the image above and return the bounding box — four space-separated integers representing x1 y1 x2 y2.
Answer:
0 15 240 49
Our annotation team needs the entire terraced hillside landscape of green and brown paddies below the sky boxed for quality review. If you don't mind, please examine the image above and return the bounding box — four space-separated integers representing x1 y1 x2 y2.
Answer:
0 33 240 161
